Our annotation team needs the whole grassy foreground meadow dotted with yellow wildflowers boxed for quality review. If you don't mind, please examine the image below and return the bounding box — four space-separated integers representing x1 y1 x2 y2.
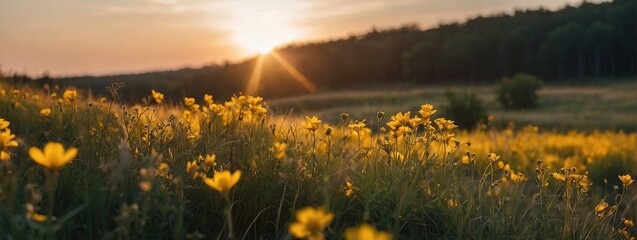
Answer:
0 84 637 239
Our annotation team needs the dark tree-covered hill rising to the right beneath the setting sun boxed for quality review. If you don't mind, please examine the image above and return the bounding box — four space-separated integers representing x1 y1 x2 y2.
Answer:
2 0 637 98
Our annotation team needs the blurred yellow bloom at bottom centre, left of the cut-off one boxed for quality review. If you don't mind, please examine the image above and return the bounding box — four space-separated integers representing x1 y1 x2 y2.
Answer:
289 207 334 240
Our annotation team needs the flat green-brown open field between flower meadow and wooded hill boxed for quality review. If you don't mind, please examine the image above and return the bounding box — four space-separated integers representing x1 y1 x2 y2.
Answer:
271 81 637 132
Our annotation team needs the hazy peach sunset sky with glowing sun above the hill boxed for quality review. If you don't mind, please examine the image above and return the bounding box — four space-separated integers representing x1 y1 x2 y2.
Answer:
0 0 596 76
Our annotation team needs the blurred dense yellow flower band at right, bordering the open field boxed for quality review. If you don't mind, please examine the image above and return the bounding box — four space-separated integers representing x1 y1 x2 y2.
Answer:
456 125 637 172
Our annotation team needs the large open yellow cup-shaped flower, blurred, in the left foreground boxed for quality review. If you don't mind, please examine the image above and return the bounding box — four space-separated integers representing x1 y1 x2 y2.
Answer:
29 142 77 170
